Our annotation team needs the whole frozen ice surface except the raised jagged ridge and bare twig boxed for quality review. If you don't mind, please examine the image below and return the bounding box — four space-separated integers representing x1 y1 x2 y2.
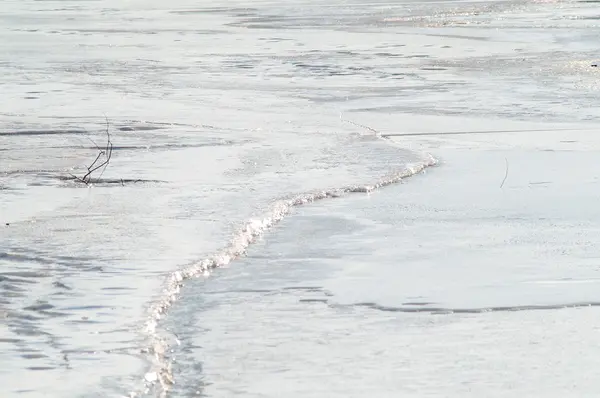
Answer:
0 0 600 397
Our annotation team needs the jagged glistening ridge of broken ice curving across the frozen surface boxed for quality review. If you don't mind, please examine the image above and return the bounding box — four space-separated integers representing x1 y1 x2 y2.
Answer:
134 154 438 397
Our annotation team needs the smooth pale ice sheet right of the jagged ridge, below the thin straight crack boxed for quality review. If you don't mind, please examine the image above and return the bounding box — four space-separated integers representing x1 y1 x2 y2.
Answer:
167 130 600 397
